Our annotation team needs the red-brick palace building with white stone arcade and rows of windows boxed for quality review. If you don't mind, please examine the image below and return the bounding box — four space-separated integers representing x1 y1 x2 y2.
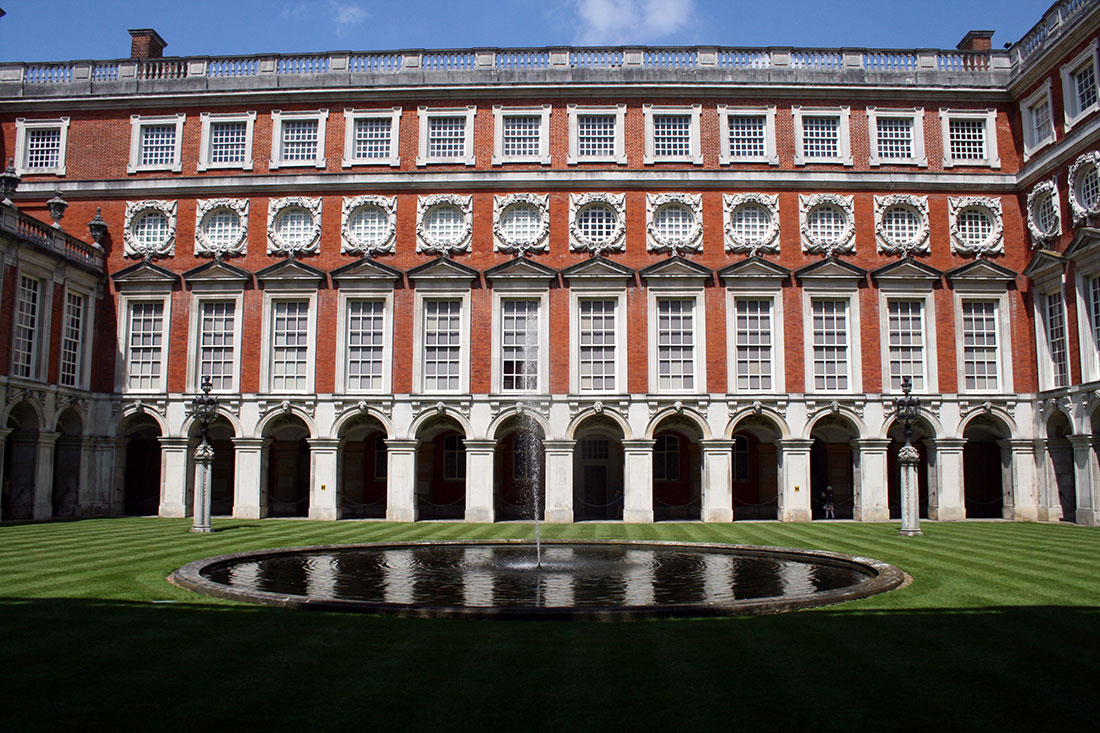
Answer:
0 0 1100 525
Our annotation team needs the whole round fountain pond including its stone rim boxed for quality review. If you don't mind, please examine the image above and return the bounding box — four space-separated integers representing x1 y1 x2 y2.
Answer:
171 541 908 619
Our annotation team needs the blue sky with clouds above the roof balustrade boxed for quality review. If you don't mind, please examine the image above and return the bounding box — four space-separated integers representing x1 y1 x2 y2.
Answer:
0 0 1049 61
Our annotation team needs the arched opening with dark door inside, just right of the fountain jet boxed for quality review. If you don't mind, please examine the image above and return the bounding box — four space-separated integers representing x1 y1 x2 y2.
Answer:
573 416 624 522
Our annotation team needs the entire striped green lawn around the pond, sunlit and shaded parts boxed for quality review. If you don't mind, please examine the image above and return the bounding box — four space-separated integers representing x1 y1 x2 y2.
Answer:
0 517 1100 731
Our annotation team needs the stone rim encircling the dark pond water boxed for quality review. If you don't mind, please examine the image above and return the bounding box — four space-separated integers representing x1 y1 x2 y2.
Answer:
167 539 912 621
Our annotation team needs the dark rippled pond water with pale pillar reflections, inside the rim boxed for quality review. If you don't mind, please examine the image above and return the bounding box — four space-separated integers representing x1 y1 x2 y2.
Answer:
202 544 873 608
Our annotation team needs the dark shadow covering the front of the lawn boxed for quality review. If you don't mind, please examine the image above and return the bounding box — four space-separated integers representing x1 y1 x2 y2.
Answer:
0 599 1100 730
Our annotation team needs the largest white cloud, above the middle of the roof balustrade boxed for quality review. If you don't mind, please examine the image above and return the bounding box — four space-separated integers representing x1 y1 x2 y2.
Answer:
575 0 695 45
